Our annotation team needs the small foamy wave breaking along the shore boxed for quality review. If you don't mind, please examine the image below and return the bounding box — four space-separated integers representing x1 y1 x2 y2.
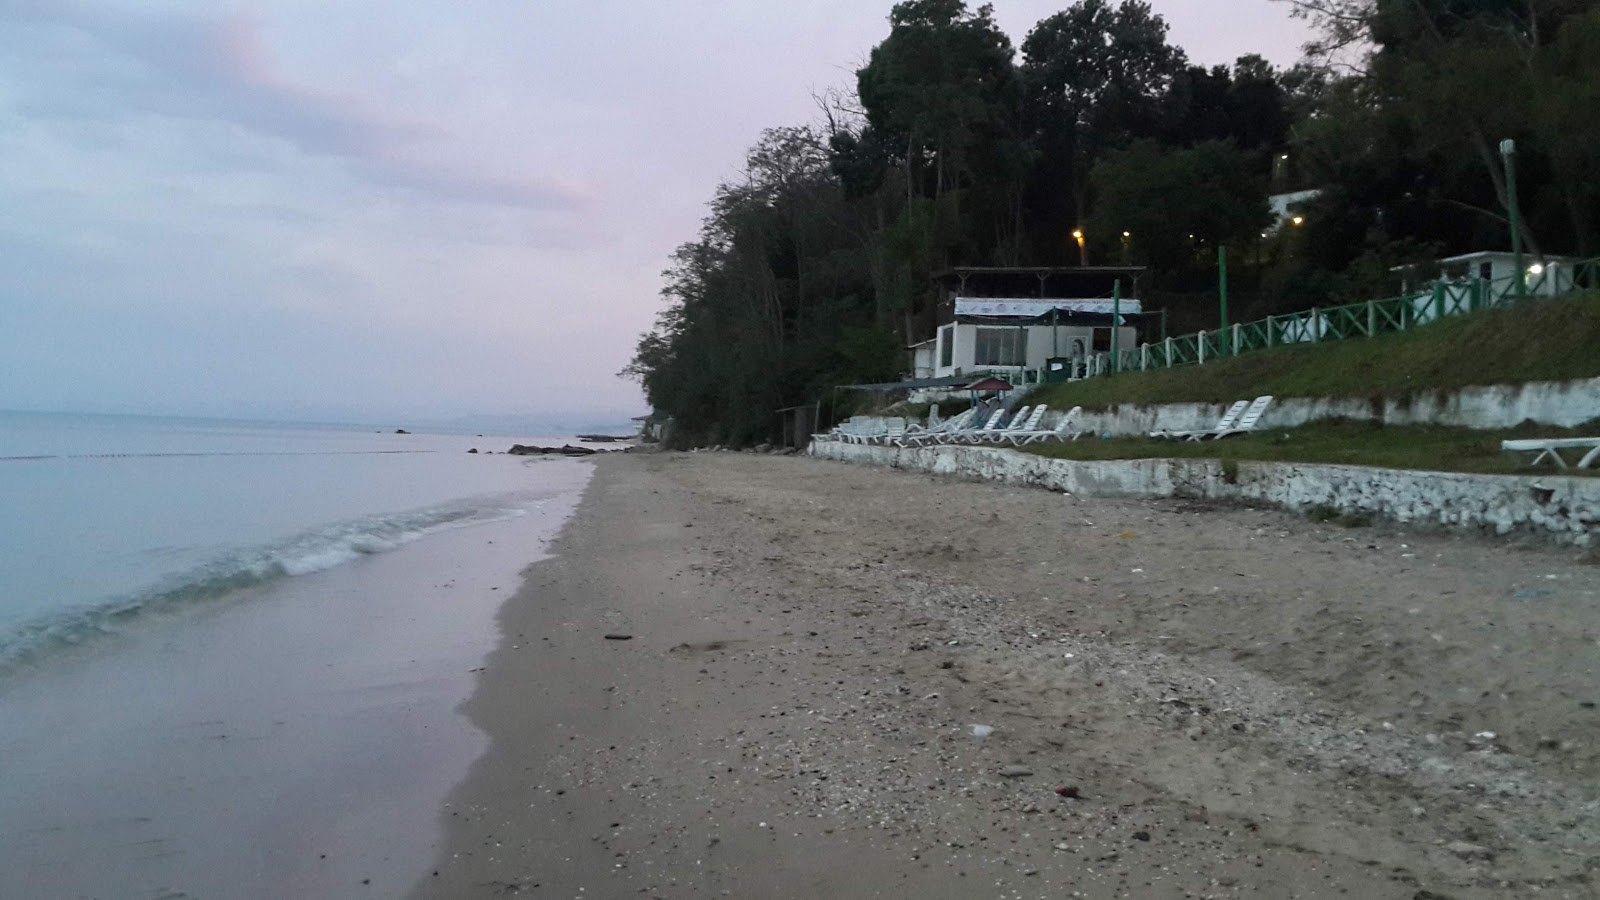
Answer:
0 496 539 673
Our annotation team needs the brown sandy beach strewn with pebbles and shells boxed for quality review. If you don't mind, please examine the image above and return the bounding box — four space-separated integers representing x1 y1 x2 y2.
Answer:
414 453 1600 900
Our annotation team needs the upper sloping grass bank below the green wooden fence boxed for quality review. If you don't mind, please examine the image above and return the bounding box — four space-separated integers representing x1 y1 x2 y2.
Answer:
1024 293 1600 409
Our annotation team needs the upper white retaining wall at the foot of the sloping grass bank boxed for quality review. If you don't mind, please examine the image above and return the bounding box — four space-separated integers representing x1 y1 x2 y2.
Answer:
1068 378 1600 437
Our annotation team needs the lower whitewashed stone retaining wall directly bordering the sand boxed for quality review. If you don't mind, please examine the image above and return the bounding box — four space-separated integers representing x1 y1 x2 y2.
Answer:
810 440 1600 546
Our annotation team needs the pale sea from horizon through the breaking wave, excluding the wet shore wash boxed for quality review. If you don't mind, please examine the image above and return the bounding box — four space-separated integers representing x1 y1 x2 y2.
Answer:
0 413 588 674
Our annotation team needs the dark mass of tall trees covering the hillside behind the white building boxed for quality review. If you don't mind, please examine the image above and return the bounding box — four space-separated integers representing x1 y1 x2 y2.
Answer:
624 0 1600 445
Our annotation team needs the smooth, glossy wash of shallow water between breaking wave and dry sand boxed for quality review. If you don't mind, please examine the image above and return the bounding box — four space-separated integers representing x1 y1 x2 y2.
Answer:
0 466 587 898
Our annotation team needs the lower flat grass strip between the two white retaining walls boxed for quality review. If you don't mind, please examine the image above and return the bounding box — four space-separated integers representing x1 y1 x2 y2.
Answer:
1024 419 1600 477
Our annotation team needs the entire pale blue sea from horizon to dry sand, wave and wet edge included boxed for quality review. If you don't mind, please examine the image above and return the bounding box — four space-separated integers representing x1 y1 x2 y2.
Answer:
0 413 592 900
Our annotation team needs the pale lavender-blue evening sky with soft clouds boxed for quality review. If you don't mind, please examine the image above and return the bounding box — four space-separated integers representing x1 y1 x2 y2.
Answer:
0 0 1307 421
